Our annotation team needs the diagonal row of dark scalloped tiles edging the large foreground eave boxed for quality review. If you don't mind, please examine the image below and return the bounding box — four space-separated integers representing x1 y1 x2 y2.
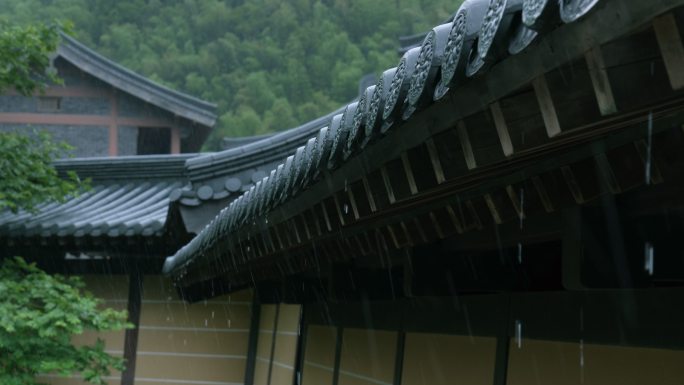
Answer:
164 0 620 274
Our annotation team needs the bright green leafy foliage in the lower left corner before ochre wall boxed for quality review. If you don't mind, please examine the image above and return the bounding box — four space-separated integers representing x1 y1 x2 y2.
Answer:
0 257 130 385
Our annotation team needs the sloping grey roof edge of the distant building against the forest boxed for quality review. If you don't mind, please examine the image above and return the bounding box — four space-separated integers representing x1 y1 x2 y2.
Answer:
57 33 216 127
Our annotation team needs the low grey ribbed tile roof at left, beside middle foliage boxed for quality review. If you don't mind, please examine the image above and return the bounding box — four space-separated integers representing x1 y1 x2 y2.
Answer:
0 155 194 238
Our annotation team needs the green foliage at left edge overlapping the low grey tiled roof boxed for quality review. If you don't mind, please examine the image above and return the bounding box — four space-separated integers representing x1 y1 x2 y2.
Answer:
0 131 88 212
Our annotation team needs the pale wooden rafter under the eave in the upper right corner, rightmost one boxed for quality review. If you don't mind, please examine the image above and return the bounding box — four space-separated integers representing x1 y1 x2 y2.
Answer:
653 13 684 90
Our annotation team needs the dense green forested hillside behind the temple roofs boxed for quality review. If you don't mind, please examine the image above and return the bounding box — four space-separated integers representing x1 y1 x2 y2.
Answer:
0 0 461 149
